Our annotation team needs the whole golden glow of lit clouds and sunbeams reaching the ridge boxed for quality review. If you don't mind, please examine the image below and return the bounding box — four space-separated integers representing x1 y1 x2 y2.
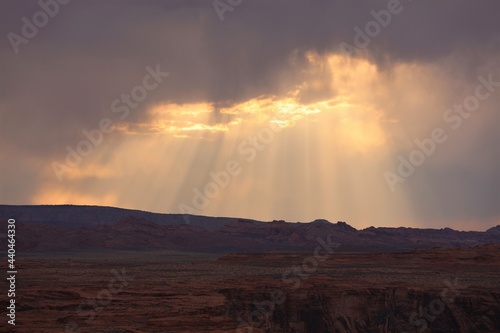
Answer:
23 52 500 227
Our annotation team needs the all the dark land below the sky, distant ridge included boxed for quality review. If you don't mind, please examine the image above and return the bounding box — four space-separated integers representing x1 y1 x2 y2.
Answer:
0 205 500 333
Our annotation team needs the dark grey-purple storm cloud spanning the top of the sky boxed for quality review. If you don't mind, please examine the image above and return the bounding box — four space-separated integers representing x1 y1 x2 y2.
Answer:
0 0 500 151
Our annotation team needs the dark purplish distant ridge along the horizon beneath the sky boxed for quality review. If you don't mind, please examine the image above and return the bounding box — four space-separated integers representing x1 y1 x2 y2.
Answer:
0 205 500 252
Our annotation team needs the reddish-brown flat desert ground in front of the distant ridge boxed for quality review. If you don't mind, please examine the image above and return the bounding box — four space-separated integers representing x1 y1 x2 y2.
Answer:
1 240 500 333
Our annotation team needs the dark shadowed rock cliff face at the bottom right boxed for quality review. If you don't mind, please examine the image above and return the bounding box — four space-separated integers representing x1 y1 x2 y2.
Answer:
223 281 500 333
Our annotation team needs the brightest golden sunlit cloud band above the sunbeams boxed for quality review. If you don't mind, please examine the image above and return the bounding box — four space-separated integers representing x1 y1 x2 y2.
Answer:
109 52 394 157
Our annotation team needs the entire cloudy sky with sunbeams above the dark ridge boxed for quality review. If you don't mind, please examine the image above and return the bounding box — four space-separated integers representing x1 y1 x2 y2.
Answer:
0 0 500 230
